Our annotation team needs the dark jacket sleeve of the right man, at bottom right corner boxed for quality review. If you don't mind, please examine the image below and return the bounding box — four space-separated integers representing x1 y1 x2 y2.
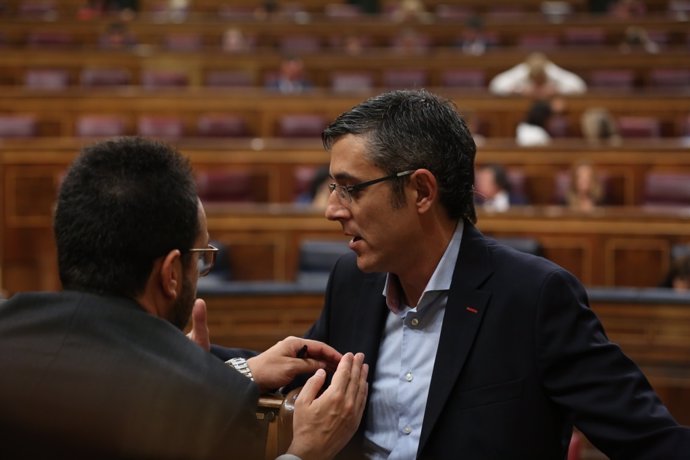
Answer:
536 270 690 460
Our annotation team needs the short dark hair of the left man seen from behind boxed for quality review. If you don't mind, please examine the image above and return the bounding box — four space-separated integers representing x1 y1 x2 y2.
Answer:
54 137 199 297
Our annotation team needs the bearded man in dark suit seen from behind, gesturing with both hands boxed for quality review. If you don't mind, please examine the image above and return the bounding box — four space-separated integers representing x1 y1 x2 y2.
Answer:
0 138 367 460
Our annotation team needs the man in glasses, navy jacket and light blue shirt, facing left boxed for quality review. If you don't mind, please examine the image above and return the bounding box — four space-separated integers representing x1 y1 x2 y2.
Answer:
307 91 690 460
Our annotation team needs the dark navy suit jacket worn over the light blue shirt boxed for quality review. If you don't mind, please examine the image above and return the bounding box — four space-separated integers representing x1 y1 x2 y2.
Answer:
307 223 690 460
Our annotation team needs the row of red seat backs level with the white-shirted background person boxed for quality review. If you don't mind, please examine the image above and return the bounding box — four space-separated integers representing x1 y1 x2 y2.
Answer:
10 67 690 92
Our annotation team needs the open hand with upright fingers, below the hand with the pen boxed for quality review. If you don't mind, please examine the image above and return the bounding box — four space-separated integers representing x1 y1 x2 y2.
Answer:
287 353 369 460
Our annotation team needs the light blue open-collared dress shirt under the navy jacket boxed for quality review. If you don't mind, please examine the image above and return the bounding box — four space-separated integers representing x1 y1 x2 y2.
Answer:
364 222 463 460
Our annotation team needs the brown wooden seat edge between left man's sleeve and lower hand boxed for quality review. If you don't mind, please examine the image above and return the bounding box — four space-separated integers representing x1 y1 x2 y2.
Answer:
256 387 302 460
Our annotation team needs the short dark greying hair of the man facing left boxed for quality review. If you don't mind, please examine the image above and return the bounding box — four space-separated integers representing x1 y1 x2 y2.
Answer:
321 89 477 222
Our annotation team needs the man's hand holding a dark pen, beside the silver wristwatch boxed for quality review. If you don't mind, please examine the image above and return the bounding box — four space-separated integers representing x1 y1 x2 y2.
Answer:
247 337 342 392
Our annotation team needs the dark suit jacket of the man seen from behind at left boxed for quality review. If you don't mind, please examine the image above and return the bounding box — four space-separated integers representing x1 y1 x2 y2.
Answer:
0 292 263 459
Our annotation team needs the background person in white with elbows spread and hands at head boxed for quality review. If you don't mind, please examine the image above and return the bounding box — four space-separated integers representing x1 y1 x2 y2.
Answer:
489 53 587 99
